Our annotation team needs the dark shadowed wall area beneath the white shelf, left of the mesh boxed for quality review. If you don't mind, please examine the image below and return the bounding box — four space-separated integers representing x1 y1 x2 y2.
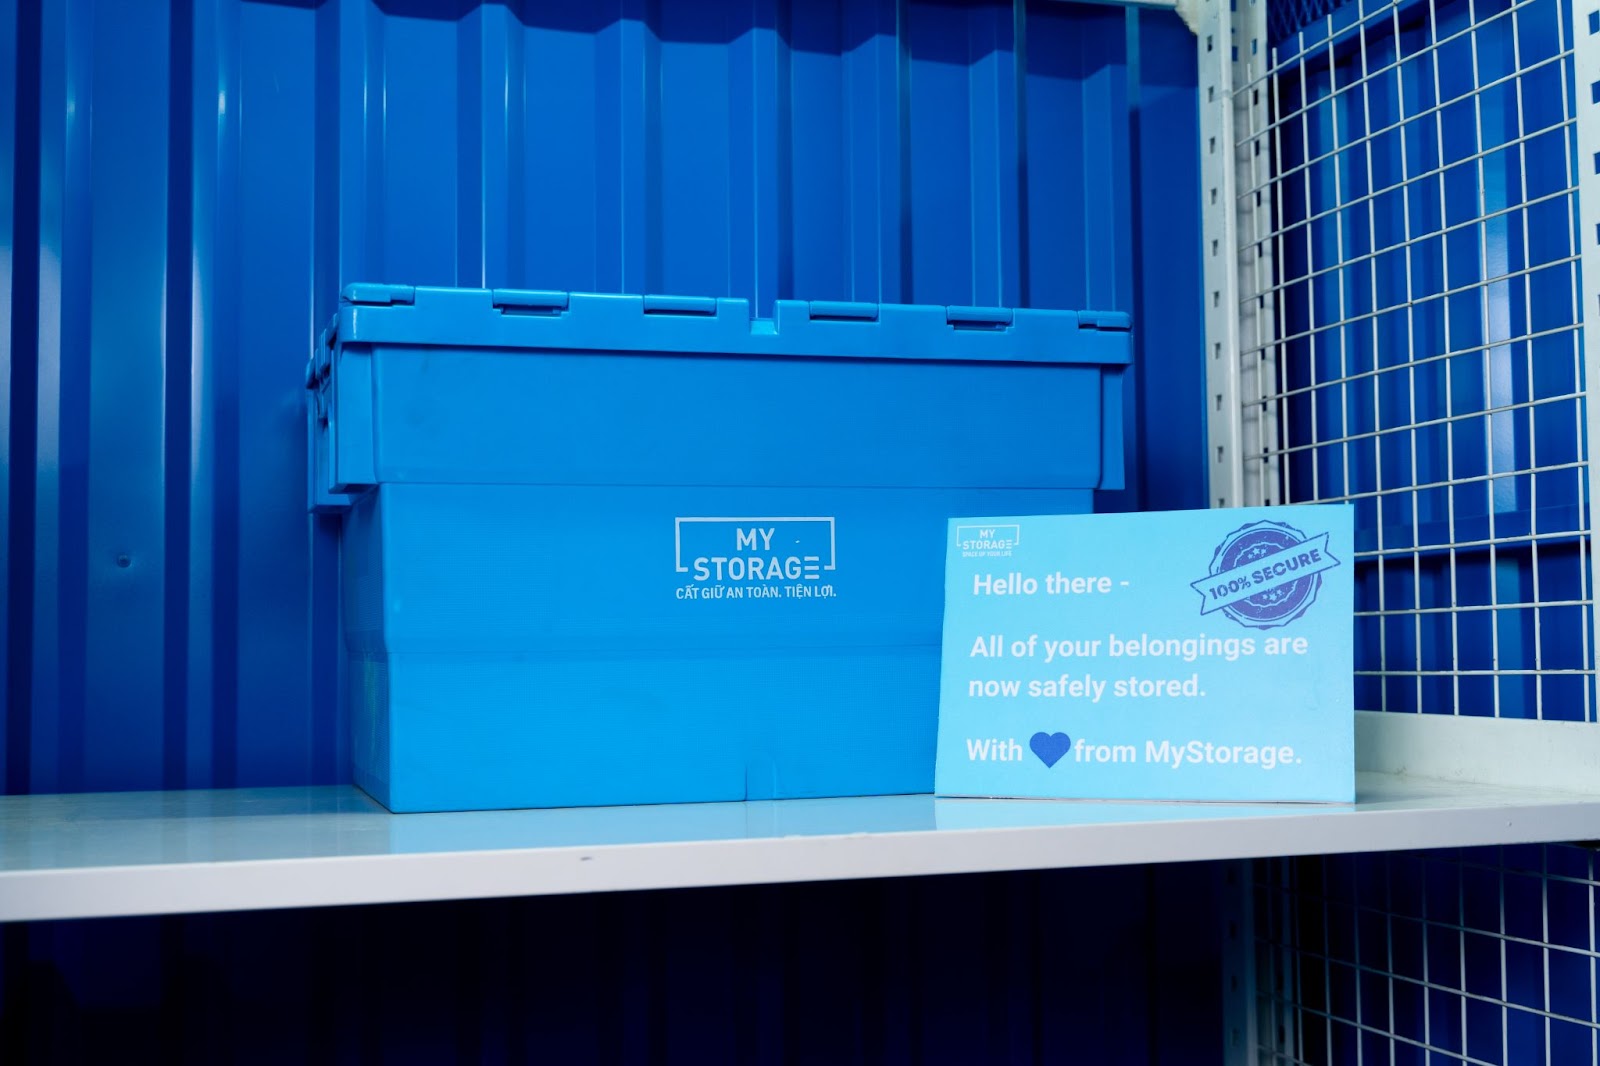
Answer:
0 866 1222 1066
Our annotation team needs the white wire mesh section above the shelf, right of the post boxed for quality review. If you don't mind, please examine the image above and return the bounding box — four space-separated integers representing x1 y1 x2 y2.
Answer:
1235 0 1595 722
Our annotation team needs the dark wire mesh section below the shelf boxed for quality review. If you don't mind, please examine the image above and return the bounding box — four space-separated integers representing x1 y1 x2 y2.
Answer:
1253 845 1600 1066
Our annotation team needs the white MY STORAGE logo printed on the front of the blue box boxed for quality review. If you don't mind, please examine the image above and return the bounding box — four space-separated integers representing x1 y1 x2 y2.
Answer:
674 517 837 600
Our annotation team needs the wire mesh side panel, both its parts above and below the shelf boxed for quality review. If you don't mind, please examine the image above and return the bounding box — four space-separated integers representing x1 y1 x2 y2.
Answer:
1235 0 1600 1066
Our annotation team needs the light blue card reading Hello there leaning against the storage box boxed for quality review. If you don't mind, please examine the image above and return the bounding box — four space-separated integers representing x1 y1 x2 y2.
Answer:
934 504 1355 802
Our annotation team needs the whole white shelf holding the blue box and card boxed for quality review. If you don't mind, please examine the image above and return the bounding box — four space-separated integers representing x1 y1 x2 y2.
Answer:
0 773 1600 920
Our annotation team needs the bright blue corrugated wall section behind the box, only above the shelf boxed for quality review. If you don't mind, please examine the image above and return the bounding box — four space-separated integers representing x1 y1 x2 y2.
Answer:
0 0 1203 792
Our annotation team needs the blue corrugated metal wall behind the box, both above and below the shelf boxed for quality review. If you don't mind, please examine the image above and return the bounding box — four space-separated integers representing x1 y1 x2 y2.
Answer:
0 0 1221 1063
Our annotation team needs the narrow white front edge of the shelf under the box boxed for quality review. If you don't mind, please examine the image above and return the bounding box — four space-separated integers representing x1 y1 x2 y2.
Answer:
0 781 1600 922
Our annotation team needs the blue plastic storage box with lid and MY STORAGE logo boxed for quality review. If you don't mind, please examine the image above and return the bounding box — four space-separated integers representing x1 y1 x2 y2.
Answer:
307 285 1128 812
